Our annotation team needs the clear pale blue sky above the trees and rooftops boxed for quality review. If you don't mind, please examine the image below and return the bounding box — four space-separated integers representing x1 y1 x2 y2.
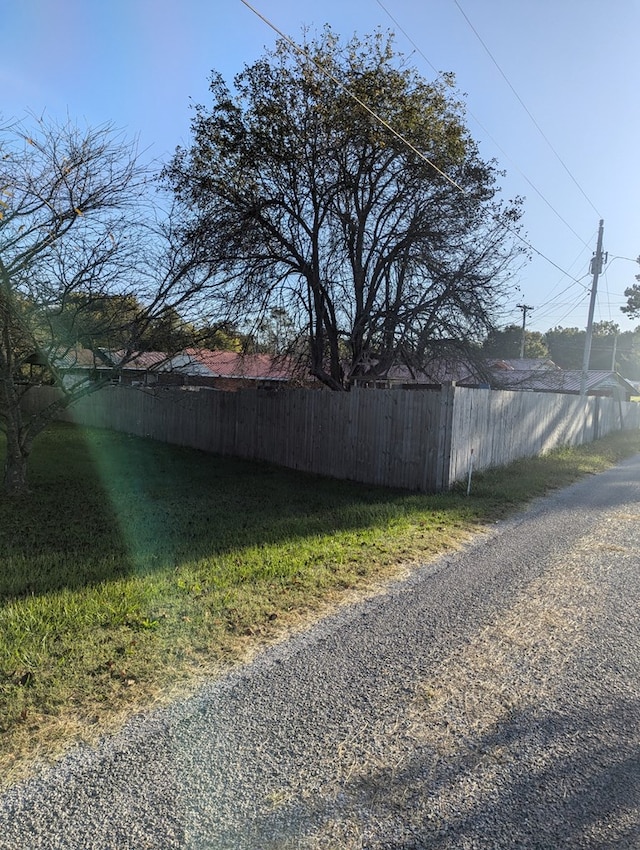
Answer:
0 0 640 331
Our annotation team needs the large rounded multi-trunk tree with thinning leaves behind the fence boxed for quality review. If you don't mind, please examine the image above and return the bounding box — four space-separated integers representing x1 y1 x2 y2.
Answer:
165 28 522 389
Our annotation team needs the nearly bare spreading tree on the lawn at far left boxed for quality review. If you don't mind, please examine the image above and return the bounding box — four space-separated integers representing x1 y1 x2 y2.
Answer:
0 118 207 493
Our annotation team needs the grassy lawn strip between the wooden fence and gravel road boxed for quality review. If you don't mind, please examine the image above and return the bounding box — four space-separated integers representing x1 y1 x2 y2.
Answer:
0 425 640 784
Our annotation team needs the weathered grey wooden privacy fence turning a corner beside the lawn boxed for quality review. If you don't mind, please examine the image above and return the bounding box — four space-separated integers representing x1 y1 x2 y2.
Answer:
24 385 640 492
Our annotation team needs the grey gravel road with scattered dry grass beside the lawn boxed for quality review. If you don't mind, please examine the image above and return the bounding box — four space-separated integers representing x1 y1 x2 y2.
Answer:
0 456 640 850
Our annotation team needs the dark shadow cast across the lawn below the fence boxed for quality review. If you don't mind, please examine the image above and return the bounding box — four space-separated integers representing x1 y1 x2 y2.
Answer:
0 424 446 598
